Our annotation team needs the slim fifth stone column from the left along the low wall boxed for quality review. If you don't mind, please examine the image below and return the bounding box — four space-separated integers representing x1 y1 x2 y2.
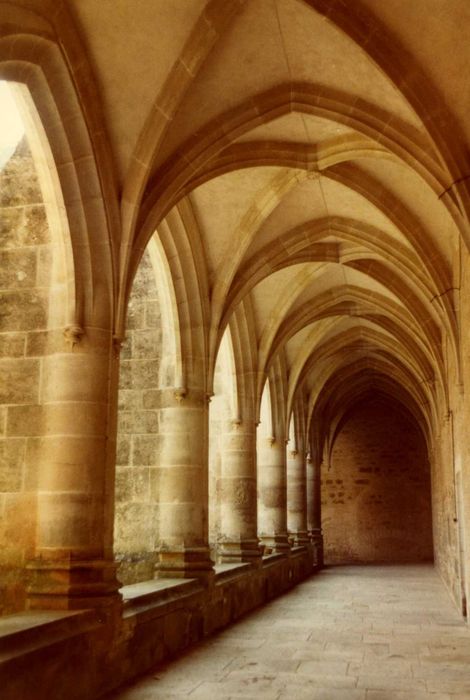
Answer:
287 450 310 546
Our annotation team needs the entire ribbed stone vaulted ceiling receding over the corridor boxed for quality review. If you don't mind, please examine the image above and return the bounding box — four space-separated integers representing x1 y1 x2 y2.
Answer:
71 0 470 438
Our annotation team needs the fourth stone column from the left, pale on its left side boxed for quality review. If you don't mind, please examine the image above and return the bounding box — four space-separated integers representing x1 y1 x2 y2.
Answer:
257 436 290 552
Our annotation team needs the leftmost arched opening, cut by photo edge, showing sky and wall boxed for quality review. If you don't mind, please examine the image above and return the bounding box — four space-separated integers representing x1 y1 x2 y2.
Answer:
0 81 74 614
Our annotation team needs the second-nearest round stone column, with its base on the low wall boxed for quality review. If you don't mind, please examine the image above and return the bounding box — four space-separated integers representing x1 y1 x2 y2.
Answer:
156 389 213 578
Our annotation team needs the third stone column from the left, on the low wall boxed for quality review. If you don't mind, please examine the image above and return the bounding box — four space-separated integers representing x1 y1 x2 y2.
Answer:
219 420 261 562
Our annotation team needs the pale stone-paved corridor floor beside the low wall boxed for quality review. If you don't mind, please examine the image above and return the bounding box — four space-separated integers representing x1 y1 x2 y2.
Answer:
110 566 470 700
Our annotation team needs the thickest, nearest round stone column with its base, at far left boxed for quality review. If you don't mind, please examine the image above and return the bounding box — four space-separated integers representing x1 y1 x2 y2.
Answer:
25 327 120 609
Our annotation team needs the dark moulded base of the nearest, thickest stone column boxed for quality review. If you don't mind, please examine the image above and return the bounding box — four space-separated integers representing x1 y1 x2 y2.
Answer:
26 558 122 610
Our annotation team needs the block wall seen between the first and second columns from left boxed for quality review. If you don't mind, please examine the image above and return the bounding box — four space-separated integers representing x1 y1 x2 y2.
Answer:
114 251 162 585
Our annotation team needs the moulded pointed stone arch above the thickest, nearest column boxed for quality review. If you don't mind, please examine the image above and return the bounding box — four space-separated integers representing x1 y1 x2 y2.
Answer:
0 0 120 328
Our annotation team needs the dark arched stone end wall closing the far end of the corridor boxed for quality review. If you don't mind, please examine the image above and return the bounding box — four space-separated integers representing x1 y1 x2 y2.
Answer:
322 398 433 564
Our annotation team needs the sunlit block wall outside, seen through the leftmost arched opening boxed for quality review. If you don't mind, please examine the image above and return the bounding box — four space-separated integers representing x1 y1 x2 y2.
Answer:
0 139 52 614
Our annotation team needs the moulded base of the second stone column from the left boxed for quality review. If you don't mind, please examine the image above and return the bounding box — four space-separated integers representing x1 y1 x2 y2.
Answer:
155 547 214 580
